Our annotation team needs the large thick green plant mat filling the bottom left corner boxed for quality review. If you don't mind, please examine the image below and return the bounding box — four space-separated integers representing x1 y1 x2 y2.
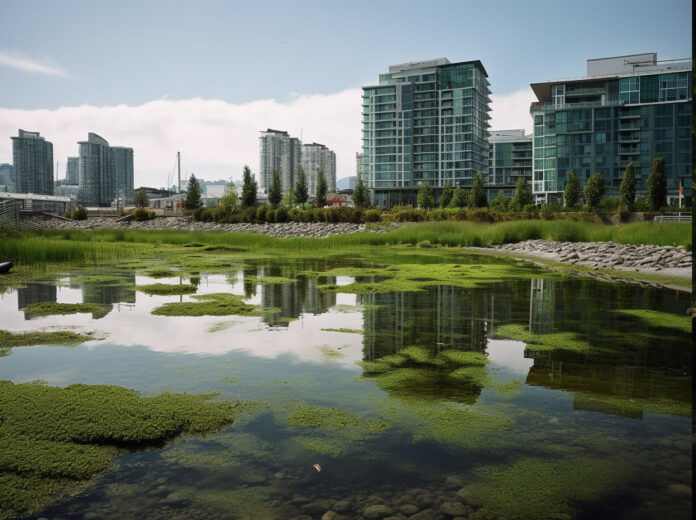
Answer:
0 381 254 519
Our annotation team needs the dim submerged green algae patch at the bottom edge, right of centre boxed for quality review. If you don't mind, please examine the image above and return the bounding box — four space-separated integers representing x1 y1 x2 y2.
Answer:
459 456 630 520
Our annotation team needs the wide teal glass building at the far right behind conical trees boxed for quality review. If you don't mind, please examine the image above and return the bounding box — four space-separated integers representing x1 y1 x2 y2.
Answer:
530 53 693 204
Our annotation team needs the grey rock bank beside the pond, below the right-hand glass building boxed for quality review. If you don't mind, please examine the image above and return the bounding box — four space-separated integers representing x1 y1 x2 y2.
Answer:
492 240 692 276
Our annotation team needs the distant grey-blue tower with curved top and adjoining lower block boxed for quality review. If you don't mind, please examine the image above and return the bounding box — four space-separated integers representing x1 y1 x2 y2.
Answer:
78 132 133 206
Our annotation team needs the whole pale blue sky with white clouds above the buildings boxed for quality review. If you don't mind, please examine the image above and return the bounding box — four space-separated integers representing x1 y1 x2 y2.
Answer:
0 0 692 187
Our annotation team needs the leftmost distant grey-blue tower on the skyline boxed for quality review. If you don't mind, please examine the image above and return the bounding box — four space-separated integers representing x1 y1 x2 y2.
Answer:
12 129 53 195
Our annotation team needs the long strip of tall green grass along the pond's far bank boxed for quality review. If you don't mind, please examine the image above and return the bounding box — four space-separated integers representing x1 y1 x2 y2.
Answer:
0 220 692 263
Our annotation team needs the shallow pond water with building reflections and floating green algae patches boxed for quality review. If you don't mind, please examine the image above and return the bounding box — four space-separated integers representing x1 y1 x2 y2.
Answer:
0 250 692 519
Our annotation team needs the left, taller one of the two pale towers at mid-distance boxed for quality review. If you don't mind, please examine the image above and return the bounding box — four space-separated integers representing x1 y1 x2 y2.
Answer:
259 128 302 193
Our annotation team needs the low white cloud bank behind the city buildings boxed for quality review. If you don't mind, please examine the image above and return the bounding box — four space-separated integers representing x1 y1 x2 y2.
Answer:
0 88 533 187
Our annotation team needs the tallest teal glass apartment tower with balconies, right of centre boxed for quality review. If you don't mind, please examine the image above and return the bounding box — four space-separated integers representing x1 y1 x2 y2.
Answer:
362 58 490 207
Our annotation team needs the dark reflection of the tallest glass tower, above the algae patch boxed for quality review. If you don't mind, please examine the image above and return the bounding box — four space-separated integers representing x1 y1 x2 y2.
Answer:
358 286 495 360
